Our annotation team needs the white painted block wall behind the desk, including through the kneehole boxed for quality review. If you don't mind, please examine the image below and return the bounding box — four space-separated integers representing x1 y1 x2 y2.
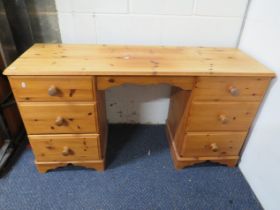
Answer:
56 0 247 123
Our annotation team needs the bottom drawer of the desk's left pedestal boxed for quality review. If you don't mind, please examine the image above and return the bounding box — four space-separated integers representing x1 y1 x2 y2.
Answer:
28 134 100 162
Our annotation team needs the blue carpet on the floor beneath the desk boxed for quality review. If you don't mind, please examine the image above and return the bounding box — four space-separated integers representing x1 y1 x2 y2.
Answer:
0 125 262 210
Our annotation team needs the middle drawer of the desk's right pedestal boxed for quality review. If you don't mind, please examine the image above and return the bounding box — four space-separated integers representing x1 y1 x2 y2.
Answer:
187 102 259 131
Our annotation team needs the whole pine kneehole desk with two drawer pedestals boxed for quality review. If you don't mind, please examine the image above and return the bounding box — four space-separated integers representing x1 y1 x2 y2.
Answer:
4 44 275 172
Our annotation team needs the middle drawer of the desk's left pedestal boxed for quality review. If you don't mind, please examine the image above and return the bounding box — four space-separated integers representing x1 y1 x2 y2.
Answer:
19 102 97 134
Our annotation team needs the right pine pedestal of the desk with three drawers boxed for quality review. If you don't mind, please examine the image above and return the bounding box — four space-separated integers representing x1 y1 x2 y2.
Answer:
167 77 271 169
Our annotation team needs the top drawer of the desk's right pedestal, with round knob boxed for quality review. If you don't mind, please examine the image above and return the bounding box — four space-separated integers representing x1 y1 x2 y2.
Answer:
193 77 271 101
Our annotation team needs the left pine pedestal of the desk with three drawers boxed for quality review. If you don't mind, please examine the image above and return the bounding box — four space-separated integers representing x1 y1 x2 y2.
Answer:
9 76 107 173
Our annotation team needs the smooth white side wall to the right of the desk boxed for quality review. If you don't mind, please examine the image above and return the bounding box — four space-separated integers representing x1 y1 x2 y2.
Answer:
239 0 280 210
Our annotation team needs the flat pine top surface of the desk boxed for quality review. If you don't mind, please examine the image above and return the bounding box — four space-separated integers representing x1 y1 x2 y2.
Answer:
4 44 275 77
